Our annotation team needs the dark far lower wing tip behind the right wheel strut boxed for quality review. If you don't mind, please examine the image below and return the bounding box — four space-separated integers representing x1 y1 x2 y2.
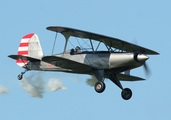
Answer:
116 74 145 81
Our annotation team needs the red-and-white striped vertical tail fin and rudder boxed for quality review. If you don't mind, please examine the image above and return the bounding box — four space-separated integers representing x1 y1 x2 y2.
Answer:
16 33 43 67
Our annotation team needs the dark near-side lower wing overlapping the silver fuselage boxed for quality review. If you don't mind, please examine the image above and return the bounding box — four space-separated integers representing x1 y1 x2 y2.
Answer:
42 56 93 71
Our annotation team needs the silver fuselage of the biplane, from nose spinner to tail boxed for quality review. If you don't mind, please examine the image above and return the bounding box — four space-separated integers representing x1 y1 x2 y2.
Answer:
29 51 148 74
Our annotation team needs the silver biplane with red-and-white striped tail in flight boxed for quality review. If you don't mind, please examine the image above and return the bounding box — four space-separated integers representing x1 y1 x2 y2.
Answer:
8 26 159 100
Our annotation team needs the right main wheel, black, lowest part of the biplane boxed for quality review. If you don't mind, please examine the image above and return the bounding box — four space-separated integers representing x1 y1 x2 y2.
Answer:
121 88 132 100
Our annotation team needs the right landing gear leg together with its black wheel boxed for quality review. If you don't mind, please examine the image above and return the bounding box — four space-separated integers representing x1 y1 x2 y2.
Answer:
110 74 132 100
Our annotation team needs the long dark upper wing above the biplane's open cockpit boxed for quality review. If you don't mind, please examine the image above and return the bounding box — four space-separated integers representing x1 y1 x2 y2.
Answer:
46 26 159 54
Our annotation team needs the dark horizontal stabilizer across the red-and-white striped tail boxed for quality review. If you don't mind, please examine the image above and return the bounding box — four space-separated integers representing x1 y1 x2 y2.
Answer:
8 55 40 62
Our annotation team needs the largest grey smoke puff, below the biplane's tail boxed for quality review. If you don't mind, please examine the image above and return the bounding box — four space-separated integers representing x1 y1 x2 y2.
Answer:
21 73 44 98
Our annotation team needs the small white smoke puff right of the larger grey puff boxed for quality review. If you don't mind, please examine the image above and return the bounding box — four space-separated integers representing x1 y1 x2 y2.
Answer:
48 78 67 92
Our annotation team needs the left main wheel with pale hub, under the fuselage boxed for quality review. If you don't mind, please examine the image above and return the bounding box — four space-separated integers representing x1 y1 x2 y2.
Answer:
94 81 106 93
